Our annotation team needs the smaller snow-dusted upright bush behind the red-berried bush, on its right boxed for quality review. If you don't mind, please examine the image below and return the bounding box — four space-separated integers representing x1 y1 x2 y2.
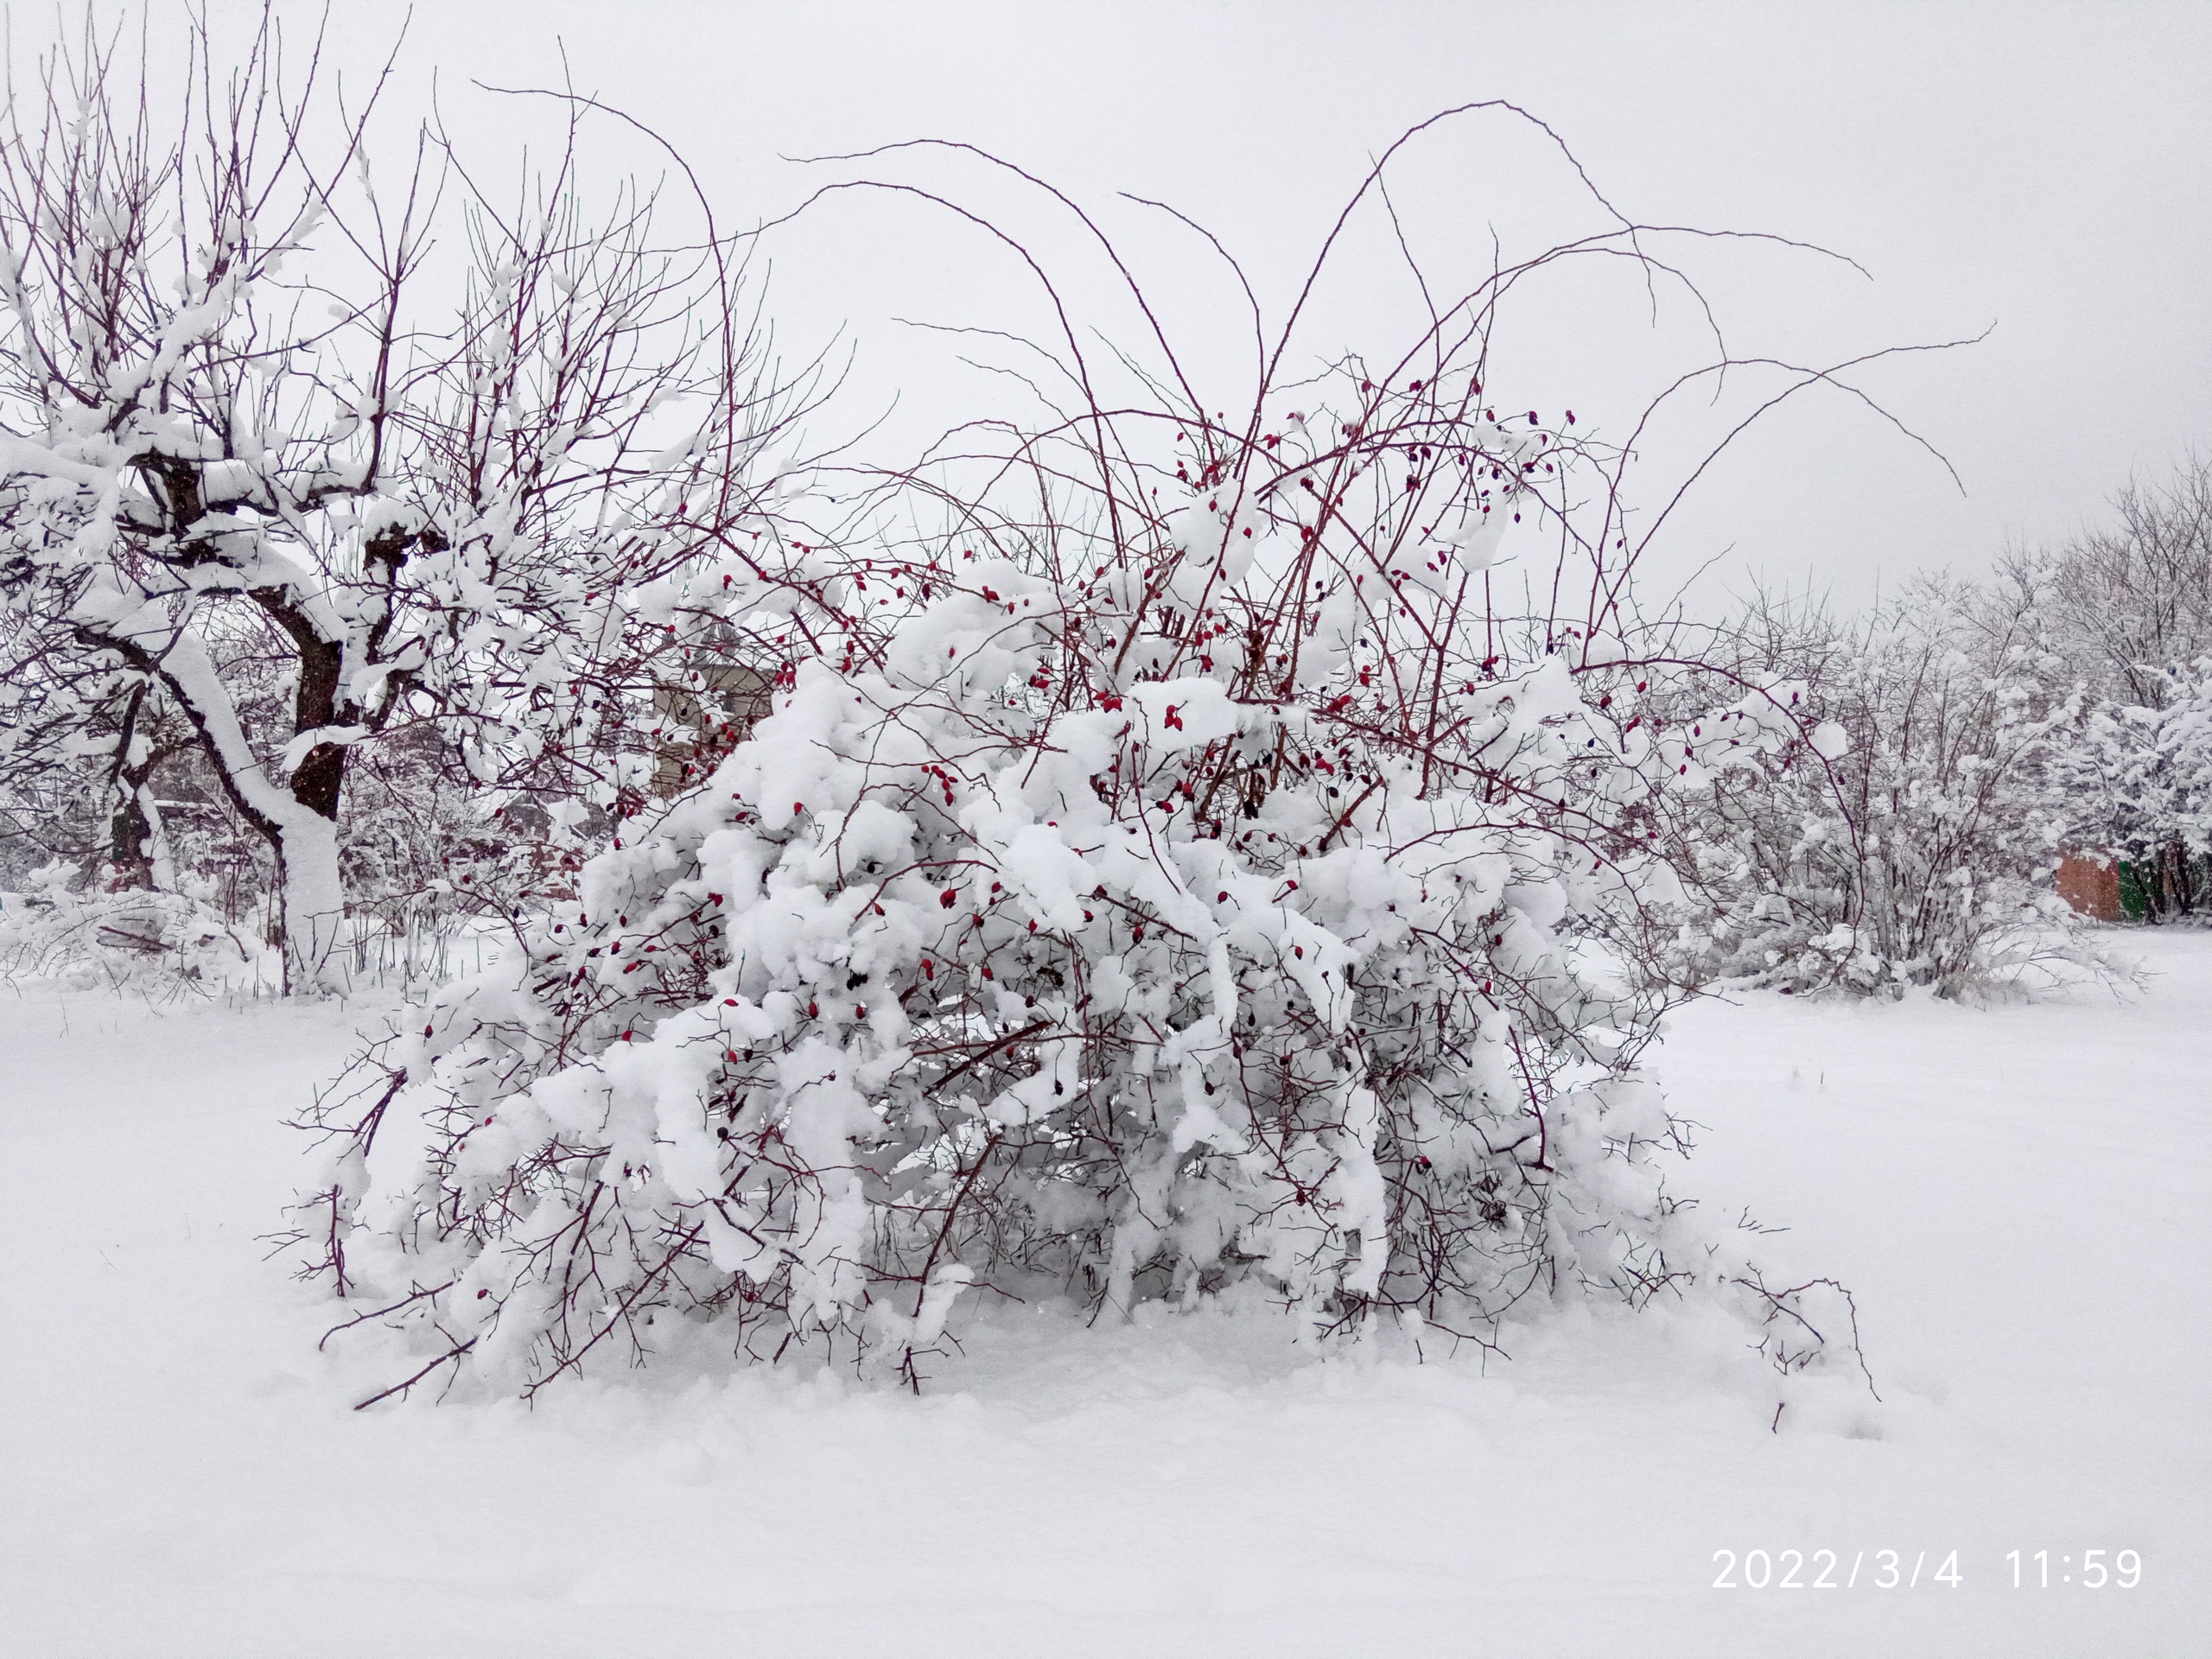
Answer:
1686 577 2106 995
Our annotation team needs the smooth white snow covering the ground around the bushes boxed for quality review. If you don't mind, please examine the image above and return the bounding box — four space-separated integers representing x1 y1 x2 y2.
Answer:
0 931 2212 1659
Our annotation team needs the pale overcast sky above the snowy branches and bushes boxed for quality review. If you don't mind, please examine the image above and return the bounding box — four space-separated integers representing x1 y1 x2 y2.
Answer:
104 0 2212 601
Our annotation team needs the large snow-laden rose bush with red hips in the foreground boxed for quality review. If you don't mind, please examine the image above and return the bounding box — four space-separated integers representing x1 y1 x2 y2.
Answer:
301 137 1885 1394
